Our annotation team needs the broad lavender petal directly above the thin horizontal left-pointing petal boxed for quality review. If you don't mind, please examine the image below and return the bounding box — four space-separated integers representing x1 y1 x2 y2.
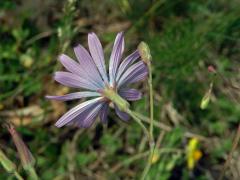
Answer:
54 71 99 91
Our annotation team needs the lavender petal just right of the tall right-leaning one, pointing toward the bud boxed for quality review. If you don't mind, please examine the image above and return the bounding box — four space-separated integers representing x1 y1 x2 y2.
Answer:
116 50 140 81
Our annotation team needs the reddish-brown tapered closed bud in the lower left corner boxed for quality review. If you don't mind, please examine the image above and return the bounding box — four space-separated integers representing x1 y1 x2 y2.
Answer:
7 125 35 169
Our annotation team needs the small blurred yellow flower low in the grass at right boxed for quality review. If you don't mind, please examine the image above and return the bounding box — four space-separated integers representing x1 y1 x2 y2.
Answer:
186 138 202 170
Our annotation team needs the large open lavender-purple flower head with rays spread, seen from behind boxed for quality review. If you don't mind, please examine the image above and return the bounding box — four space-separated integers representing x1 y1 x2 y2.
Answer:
46 32 148 128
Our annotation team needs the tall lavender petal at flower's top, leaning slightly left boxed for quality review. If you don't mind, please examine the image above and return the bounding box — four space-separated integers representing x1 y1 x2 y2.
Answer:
88 33 108 84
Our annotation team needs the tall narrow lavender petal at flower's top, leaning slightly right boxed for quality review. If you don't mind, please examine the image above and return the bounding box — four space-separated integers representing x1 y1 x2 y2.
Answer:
109 32 124 86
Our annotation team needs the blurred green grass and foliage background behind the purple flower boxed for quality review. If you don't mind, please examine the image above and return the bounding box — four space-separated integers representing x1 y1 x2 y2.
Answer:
0 0 240 180
